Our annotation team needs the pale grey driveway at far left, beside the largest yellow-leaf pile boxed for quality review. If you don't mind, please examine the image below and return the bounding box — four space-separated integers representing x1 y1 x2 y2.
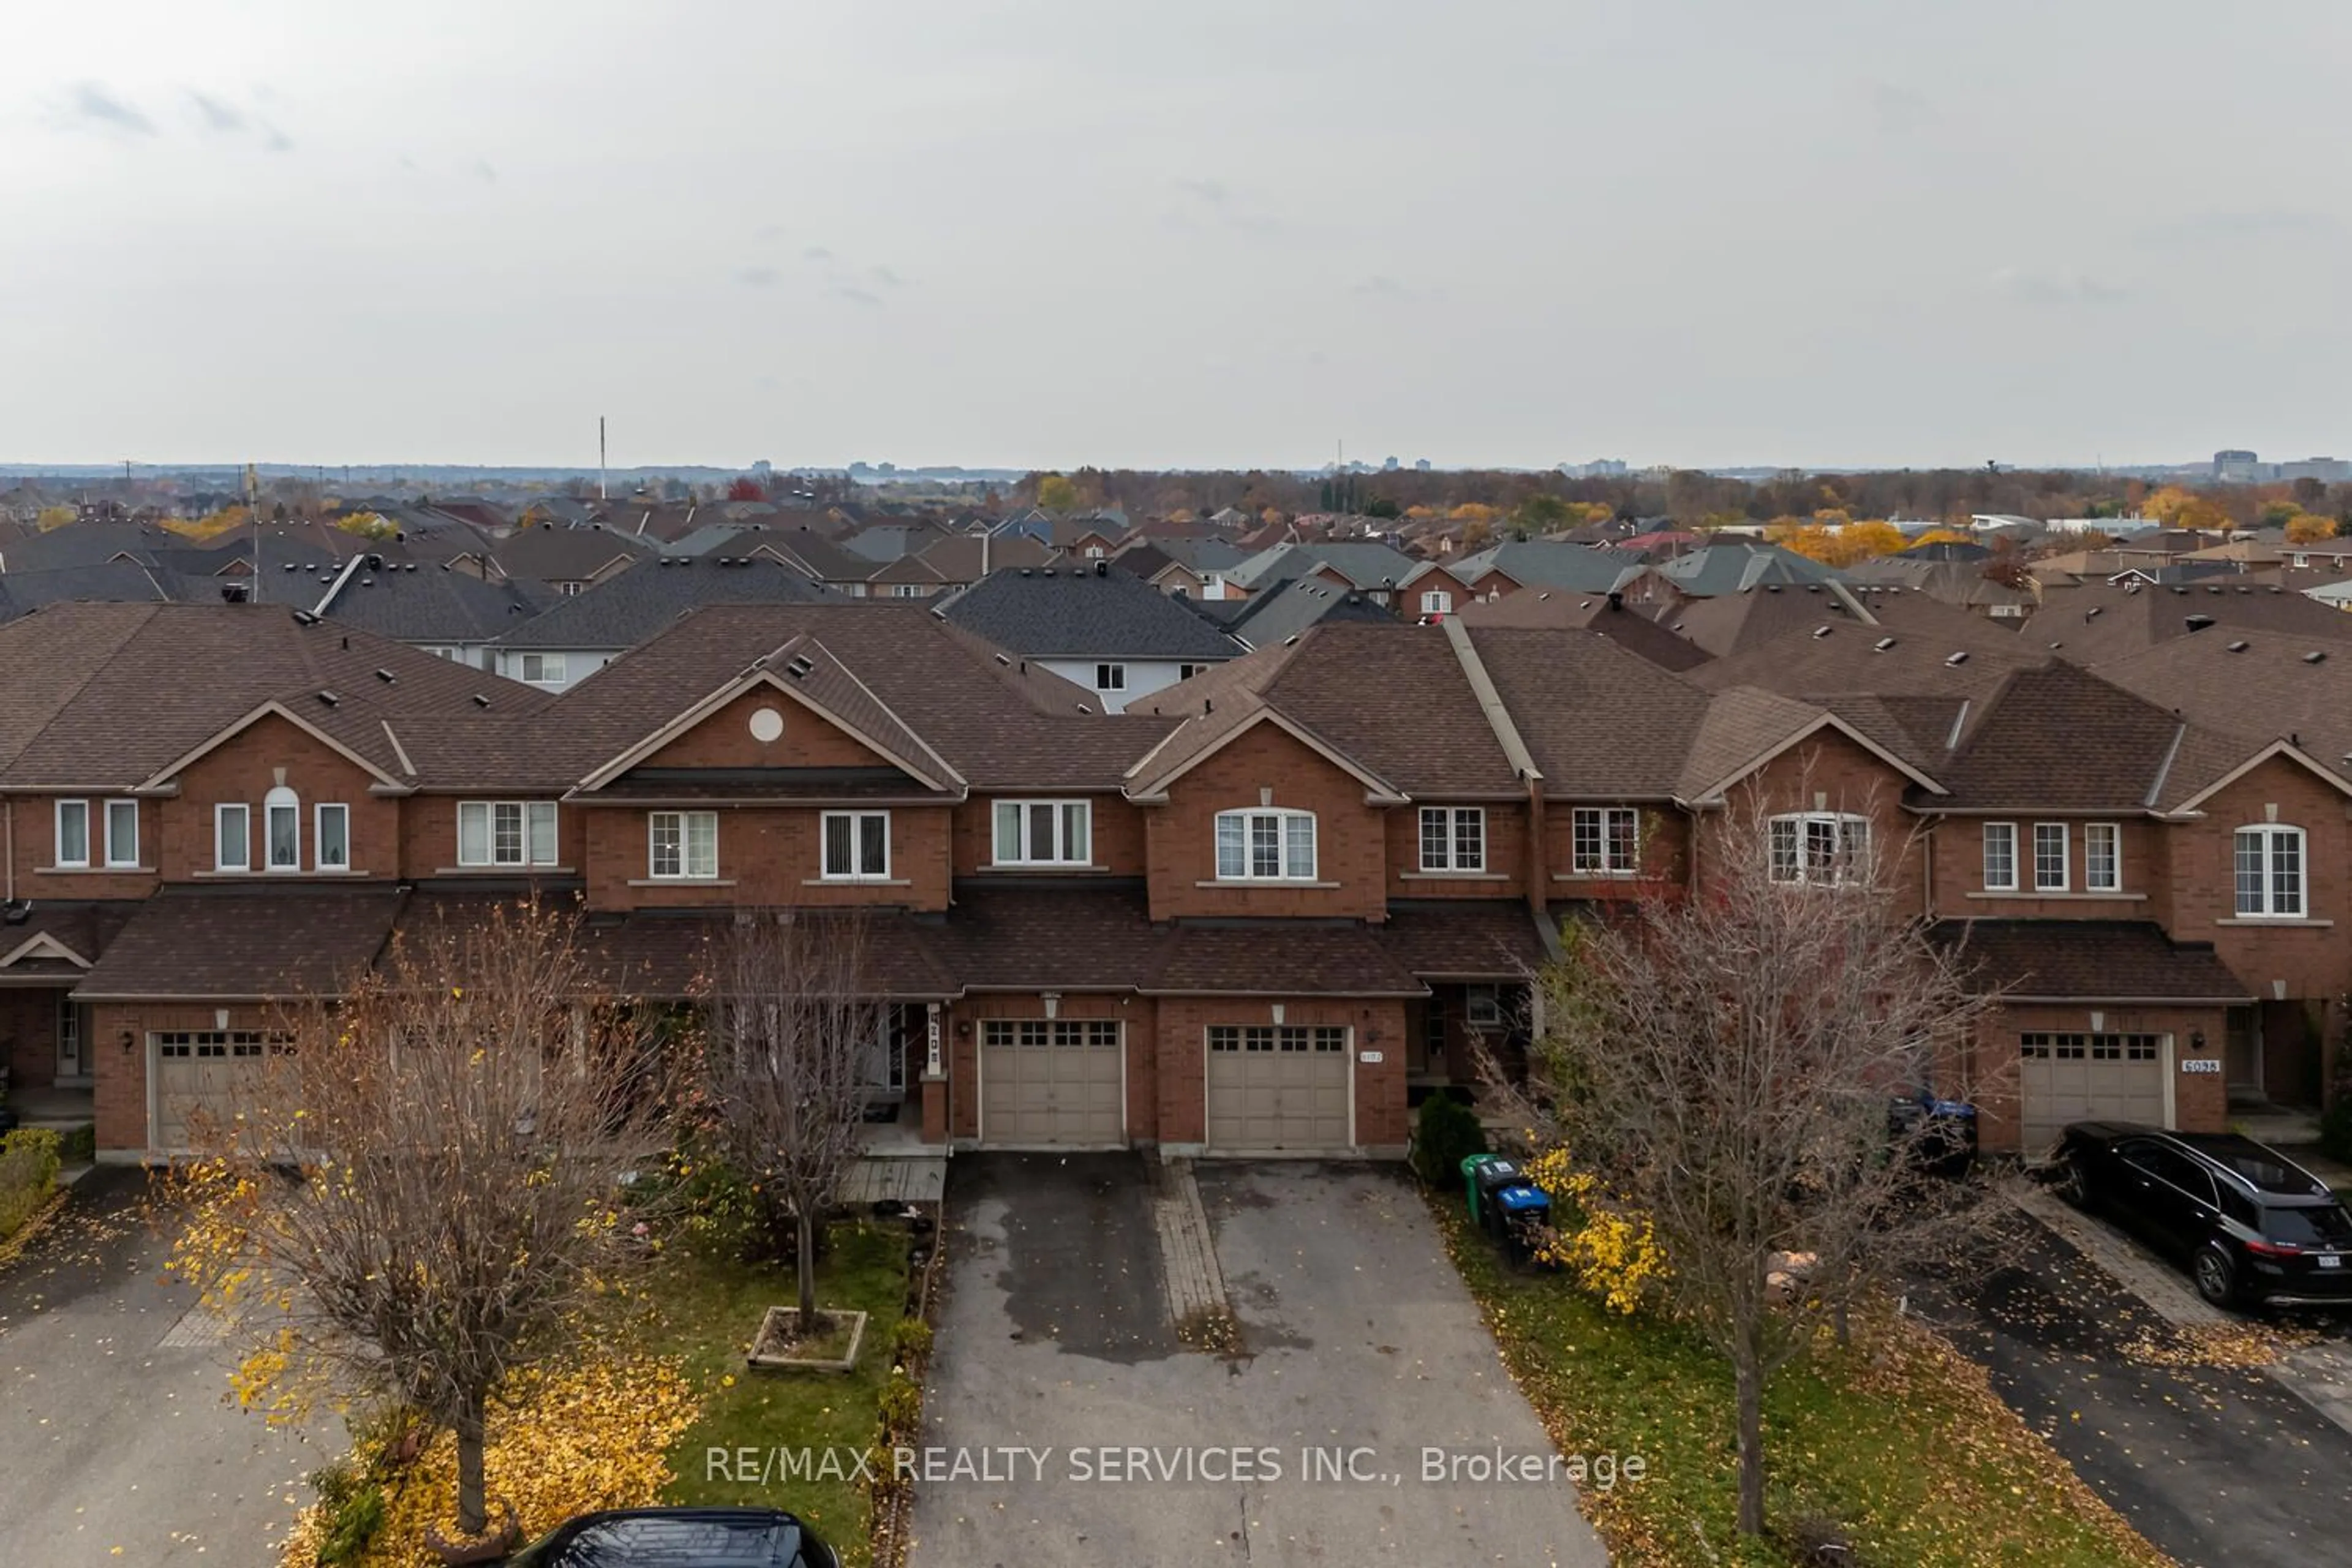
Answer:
0 1169 331 1568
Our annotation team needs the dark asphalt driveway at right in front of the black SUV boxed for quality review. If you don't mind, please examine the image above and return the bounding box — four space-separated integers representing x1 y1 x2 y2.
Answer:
1924 1215 2352 1568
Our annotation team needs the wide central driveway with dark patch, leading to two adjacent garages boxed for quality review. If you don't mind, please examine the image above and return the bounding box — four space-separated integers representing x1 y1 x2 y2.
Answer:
913 1154 1607 1568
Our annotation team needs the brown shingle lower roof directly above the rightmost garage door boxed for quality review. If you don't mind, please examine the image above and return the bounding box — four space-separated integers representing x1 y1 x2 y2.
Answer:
1929 919 2253 1001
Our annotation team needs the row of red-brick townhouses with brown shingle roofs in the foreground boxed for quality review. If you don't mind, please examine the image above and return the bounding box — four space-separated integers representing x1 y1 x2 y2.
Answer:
0 602 2352 1159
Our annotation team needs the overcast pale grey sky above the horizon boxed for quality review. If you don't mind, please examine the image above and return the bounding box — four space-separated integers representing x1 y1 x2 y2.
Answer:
0 0 2352 468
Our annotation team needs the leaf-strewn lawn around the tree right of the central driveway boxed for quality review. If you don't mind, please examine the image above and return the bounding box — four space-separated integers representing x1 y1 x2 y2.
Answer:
1437 1204 2168 1568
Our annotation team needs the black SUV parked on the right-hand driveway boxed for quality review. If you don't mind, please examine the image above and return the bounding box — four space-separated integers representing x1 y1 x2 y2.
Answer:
2049 1121 2352 1307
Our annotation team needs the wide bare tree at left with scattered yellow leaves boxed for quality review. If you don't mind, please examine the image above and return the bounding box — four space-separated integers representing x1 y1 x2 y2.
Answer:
174 903 680 1535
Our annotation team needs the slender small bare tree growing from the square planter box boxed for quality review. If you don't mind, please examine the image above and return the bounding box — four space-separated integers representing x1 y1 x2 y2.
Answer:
706 910 887 1330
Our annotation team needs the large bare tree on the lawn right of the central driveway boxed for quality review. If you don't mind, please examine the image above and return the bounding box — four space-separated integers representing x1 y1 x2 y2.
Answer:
1521 792 1994 1532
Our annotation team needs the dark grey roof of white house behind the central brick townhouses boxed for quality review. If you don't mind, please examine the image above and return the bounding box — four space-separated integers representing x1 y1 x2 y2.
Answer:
941 567 1242 661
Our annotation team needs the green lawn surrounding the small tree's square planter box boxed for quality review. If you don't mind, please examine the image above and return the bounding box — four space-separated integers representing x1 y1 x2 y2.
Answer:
647 1225 905 1563
